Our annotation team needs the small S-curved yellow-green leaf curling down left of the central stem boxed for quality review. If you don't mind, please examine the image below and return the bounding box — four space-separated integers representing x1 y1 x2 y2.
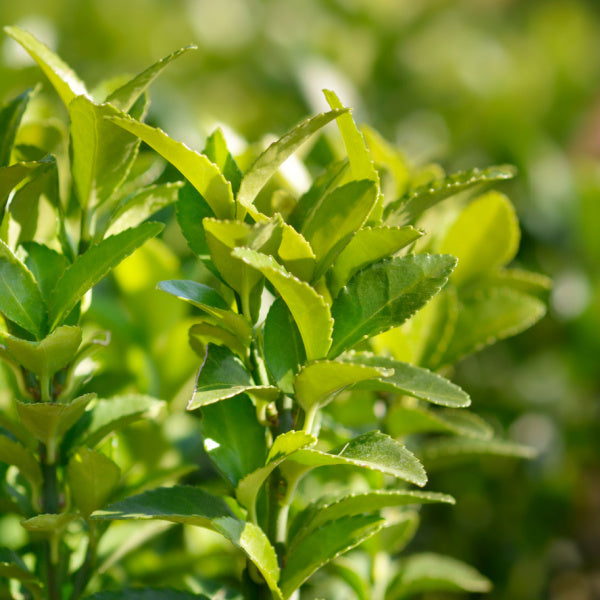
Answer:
235 431 317 514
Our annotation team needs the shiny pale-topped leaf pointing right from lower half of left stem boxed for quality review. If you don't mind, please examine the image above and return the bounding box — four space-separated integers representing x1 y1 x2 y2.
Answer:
65 394 164 448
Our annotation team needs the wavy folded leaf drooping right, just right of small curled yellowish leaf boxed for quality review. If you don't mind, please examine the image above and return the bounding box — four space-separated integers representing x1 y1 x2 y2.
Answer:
281 431 427 486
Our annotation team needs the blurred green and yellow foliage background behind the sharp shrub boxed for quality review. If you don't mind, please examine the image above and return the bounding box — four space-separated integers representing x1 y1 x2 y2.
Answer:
0 0 600 600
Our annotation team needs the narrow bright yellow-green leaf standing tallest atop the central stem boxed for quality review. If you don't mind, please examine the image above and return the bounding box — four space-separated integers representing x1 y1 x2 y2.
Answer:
323 90 383 221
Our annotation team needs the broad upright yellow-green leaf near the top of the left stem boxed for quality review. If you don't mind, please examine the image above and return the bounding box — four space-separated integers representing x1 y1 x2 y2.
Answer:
69 96 139 208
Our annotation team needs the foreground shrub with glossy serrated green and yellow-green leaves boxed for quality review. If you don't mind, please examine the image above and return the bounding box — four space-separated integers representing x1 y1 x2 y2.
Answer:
0 29 548 600
